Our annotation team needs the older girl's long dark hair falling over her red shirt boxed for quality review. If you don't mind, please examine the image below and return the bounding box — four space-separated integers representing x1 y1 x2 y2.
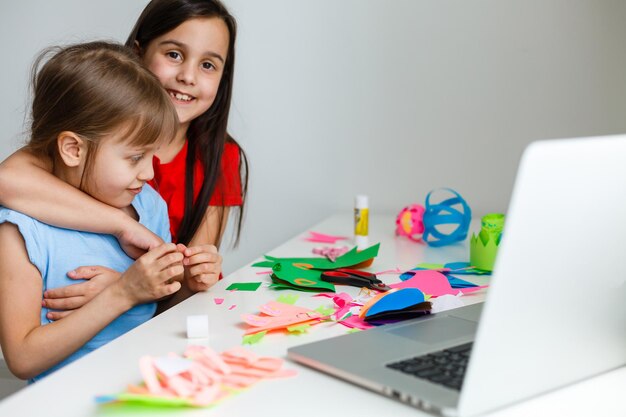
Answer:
126 0 248 246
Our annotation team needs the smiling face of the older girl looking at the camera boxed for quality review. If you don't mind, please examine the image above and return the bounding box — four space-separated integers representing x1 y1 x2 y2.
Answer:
140 17 229 129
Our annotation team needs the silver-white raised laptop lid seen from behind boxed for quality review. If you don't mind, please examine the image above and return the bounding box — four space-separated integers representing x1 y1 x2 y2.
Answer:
458 136 626 416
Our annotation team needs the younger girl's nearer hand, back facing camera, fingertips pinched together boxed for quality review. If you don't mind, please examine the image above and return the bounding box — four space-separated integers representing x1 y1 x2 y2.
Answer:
115 243 184 306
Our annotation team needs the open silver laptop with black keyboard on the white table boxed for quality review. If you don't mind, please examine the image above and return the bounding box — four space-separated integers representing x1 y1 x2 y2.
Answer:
288 135 626 417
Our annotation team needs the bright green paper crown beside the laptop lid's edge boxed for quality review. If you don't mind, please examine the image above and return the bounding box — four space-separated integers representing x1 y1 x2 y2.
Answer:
470 213 504 271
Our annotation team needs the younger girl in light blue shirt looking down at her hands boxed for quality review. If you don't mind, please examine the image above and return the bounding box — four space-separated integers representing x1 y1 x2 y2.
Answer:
0 42 213 381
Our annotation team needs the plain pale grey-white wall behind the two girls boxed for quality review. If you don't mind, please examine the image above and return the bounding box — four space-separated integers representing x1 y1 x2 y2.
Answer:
0 0 626 272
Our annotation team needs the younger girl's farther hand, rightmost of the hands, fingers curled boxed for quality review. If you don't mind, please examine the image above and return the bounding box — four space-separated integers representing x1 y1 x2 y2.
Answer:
179 245 222 292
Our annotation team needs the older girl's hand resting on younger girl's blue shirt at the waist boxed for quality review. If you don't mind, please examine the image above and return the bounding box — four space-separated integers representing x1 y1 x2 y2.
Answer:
42 266 121 320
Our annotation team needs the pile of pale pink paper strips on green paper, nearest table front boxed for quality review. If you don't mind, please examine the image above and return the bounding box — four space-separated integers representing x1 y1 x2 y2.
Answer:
96 346 295 407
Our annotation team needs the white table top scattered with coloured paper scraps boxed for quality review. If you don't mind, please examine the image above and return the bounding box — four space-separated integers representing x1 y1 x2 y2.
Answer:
0 214 626 417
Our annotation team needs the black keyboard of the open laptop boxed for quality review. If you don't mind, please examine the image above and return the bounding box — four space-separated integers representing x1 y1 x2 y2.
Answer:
387 343 472 391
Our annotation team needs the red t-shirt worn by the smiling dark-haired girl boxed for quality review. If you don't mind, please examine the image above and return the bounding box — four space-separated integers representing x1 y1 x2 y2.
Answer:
149 141 242 241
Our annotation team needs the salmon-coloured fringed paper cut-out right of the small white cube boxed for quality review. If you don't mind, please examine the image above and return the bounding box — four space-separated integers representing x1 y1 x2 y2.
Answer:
241 301 323 335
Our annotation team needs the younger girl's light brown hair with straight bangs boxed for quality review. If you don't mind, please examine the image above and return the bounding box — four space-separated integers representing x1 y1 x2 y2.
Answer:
27 42 178 183
